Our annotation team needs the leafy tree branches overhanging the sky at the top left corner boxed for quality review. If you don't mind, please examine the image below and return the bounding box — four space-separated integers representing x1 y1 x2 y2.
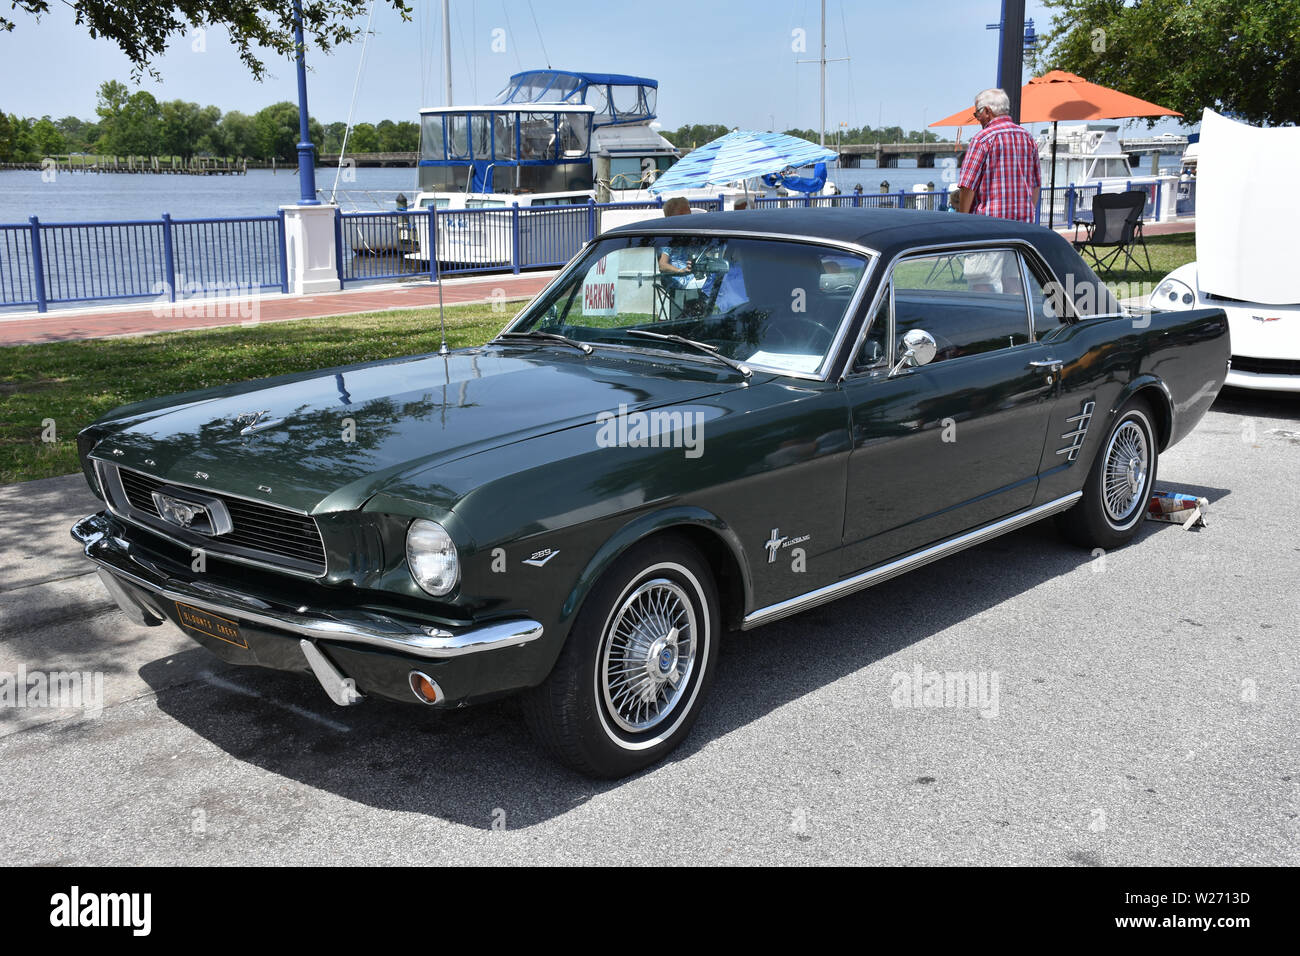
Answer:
0 0 411 79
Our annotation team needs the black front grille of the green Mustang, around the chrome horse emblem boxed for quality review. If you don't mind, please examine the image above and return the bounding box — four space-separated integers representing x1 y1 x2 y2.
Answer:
117 468 325 575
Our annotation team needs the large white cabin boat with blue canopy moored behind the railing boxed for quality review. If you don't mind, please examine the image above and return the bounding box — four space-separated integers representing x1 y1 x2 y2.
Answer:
406 69 744 268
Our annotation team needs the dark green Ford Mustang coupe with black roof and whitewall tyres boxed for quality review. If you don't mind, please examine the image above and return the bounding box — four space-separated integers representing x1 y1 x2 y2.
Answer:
73 209 1230 777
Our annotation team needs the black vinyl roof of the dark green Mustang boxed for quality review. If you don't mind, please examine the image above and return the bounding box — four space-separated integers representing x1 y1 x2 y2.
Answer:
605 208 1118 315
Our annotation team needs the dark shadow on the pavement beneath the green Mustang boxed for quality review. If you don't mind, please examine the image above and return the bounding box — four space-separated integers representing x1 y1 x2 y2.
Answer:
140 509 1226 830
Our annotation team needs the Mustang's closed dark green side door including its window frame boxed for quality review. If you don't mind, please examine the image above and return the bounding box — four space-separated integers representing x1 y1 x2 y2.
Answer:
842 246 1056 572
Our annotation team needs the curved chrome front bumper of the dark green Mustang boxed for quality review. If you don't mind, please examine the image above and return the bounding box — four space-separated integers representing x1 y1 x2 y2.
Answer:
72 514 542 659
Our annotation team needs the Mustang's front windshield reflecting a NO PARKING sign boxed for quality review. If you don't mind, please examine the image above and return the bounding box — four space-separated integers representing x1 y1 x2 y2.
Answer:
511 235 867 375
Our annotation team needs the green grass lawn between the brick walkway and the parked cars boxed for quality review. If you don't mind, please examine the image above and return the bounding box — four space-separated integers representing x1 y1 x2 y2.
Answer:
0 233 1196 483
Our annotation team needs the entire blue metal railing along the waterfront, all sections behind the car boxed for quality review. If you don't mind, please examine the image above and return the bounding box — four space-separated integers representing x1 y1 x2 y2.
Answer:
0 179 1185 312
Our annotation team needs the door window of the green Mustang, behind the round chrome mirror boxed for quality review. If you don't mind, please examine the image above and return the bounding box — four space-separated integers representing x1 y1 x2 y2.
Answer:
892 248 1030 362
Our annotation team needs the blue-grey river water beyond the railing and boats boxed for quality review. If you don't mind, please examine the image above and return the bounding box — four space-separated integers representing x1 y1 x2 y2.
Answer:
0 156 1178 224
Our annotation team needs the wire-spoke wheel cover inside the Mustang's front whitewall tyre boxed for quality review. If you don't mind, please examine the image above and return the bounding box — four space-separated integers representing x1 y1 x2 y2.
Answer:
598 578 698 734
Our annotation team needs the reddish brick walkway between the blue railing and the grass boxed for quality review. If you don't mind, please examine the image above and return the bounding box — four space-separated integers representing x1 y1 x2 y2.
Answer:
0 272 554 346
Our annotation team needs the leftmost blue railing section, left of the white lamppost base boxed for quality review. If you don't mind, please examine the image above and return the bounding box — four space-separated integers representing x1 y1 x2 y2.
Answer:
0 212 289 312
